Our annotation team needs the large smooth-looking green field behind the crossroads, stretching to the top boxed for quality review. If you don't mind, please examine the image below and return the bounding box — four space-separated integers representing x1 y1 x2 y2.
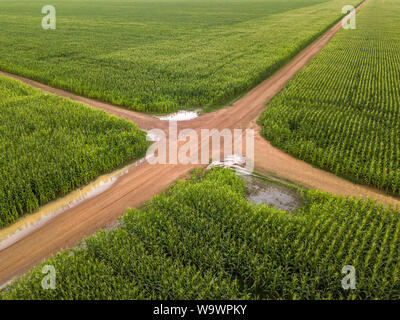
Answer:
0 0 359 112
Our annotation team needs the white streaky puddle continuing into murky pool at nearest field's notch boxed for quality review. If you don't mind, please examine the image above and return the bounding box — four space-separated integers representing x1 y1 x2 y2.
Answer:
208 155 303 213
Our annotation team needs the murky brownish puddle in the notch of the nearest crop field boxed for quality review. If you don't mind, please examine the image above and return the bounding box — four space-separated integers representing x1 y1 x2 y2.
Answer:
242 175 303 213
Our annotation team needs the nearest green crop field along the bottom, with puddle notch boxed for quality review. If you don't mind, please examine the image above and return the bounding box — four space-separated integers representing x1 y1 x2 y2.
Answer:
2 169 400 299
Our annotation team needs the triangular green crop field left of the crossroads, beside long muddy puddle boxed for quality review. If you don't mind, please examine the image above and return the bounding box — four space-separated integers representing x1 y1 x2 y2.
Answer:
0 76 147 228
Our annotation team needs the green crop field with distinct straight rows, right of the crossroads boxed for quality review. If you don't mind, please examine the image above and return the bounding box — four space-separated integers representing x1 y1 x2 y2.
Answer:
260 0 400 195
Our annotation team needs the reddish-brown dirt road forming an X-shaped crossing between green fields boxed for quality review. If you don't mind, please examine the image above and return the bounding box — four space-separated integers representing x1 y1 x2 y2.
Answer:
0 0 390 284
